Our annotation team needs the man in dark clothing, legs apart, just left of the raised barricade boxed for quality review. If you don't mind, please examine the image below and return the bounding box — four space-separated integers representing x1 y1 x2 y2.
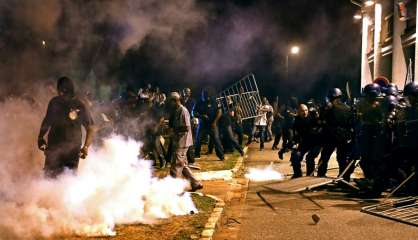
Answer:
193 90 224 160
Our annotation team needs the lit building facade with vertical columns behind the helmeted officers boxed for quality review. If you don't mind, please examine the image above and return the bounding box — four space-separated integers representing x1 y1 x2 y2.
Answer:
351 0 418 89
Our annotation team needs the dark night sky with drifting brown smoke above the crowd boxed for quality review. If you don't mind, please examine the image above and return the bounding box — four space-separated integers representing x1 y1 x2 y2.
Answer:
0 0 361 100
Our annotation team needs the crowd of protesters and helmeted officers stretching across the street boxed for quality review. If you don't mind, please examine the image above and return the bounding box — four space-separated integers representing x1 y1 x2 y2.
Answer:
38 78 418 196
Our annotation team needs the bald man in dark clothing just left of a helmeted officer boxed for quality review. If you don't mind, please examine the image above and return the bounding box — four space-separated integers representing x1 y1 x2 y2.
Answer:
290 104 320 178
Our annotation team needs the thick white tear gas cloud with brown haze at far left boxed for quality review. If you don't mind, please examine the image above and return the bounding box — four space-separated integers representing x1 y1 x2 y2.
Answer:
0 95 197 239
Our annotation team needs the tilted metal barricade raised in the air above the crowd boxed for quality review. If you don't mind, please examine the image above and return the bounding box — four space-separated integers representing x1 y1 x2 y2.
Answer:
216 73 261 120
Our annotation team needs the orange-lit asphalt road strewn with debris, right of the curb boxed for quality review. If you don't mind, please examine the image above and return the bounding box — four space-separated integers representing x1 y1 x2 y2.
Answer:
237 144 418 240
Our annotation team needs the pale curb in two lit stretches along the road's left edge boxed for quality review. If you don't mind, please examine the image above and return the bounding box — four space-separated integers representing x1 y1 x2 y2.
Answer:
199 147 248 240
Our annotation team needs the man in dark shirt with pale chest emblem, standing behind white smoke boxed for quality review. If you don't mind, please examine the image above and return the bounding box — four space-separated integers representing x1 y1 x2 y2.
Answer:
38 77 94 178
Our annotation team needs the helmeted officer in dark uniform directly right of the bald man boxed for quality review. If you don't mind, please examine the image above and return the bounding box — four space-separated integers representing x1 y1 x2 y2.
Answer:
318 88 354 181
